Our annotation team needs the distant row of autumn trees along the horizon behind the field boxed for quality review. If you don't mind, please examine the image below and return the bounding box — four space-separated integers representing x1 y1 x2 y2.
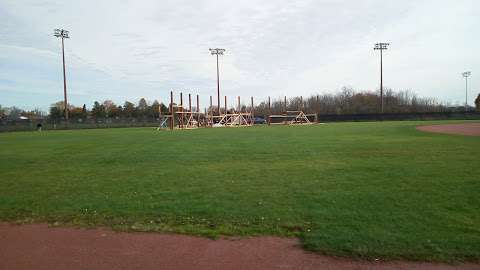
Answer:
0 87 480 121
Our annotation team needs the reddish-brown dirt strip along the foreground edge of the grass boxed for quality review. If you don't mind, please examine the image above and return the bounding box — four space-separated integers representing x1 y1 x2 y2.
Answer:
0 223 480 270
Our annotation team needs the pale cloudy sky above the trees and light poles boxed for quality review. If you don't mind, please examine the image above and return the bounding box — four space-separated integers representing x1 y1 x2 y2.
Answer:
0 0 480 110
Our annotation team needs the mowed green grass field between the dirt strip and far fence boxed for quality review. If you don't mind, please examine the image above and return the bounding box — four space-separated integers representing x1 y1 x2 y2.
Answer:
0 122 480 261
